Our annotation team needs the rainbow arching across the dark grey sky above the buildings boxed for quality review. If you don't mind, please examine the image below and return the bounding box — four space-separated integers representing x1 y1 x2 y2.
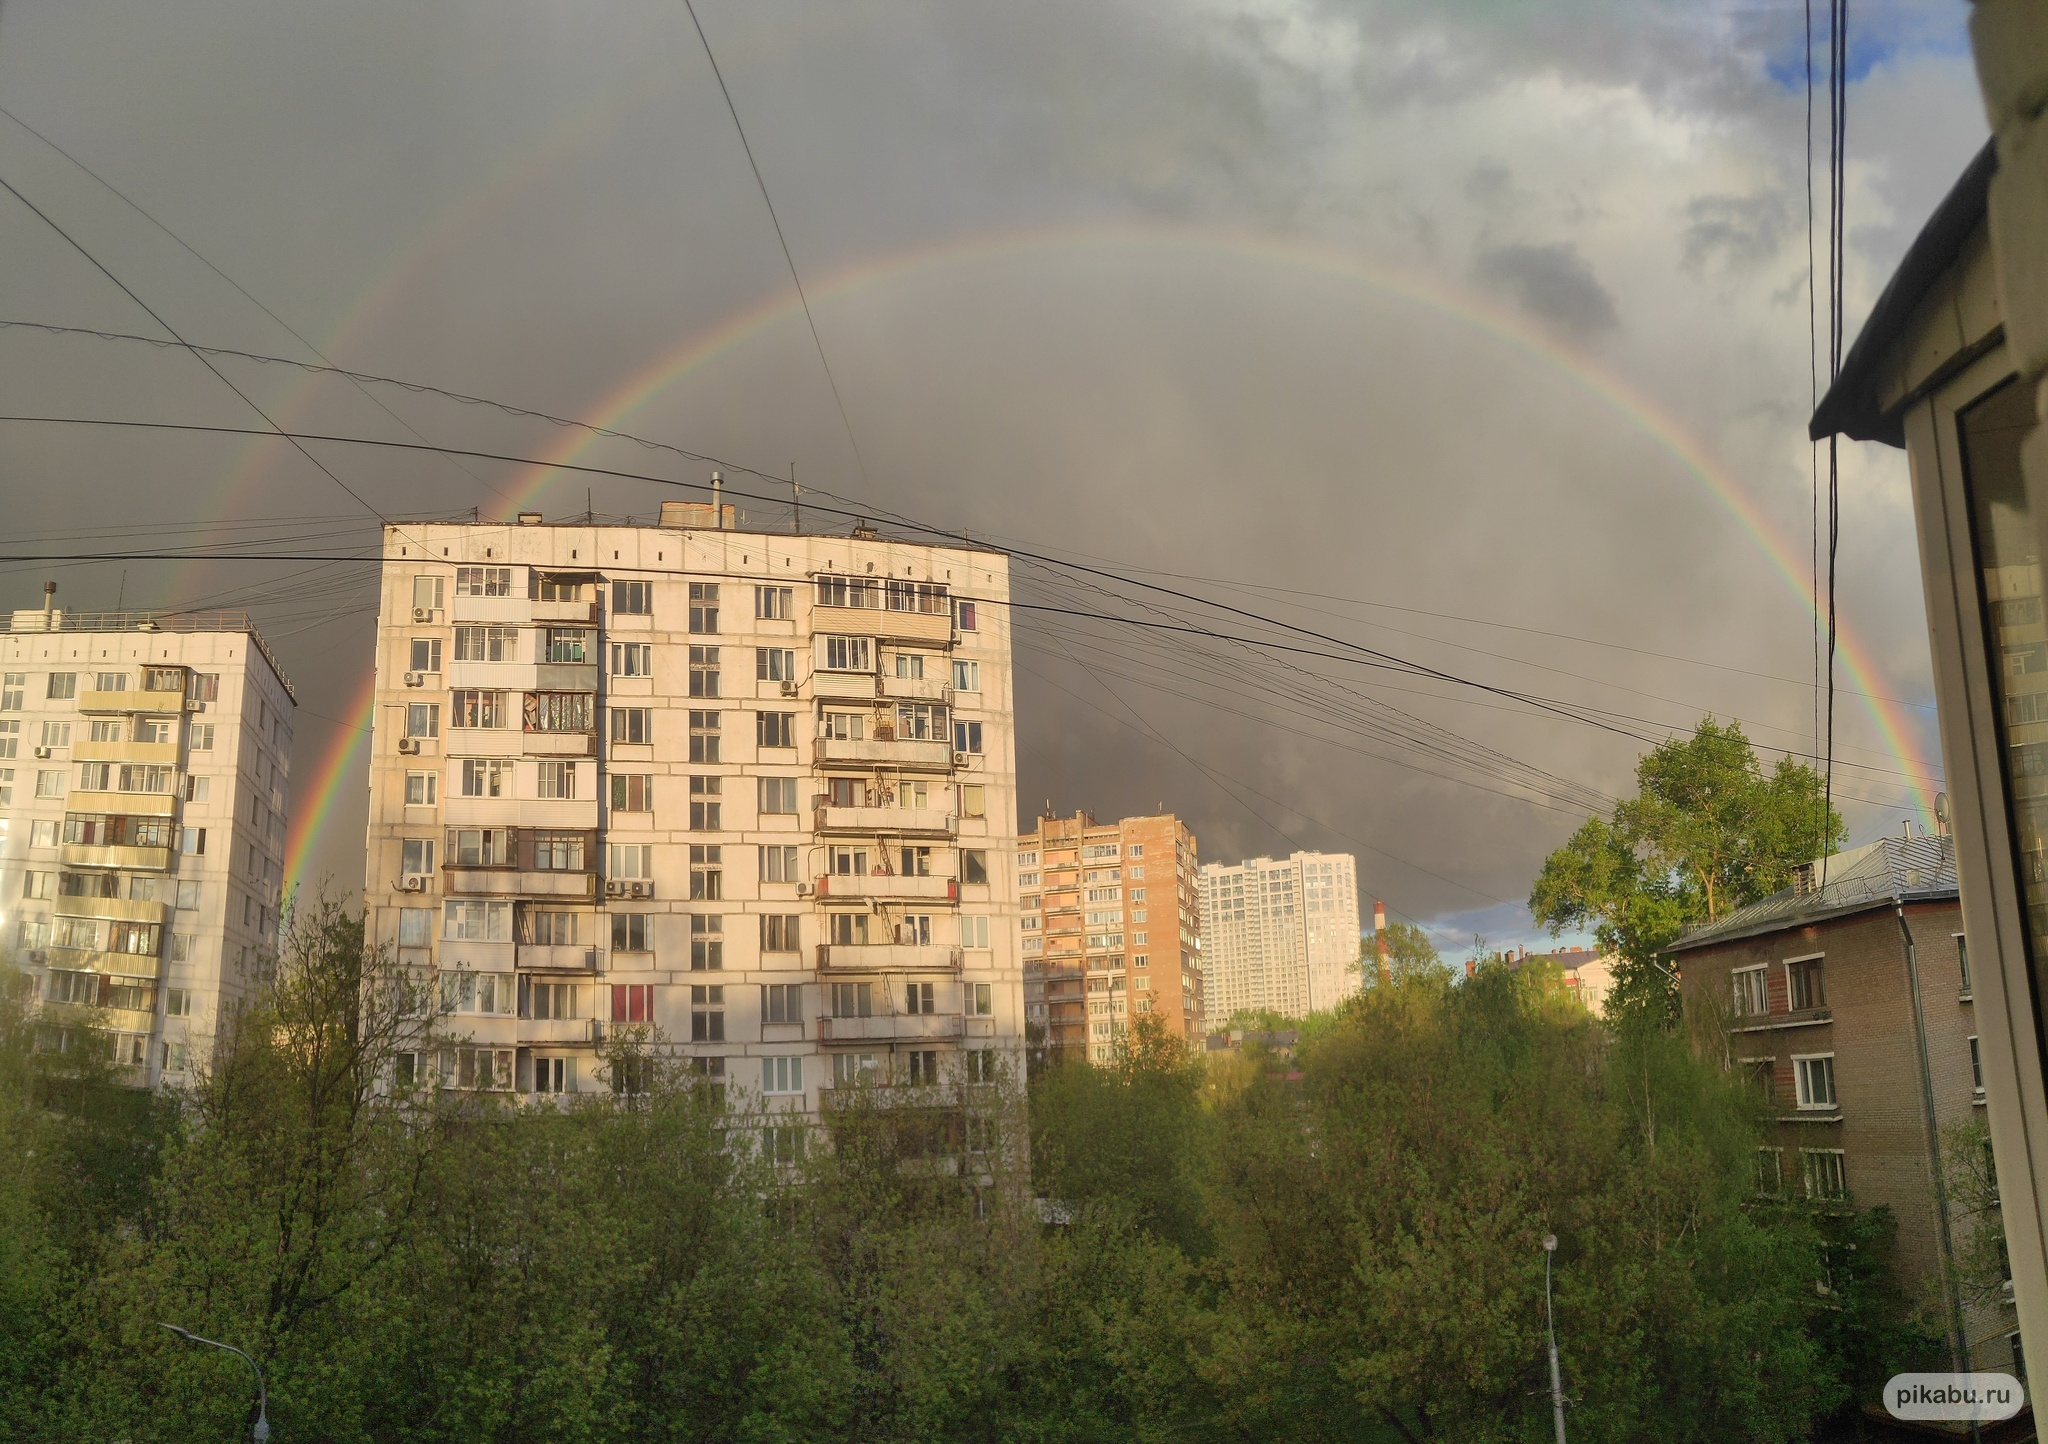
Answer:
287 225 1933 877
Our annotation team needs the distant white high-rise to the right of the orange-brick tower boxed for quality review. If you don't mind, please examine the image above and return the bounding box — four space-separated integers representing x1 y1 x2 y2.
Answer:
1200 852 1362 1026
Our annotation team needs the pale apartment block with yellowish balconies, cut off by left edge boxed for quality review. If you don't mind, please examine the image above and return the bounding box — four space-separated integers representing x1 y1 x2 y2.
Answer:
0 606 297 1086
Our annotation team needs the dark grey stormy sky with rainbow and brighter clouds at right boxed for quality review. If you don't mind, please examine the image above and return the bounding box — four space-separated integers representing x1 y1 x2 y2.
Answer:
0 0 1985 954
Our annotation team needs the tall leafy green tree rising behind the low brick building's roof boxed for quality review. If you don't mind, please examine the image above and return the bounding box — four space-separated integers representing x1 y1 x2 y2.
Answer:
1530 717 1845 1022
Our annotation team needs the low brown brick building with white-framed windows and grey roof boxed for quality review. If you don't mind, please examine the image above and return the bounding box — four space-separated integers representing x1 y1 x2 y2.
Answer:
1665 838 2019 1368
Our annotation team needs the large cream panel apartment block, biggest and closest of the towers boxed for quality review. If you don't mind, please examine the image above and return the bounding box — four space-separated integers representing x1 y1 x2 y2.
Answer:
365 504 1024 1114
